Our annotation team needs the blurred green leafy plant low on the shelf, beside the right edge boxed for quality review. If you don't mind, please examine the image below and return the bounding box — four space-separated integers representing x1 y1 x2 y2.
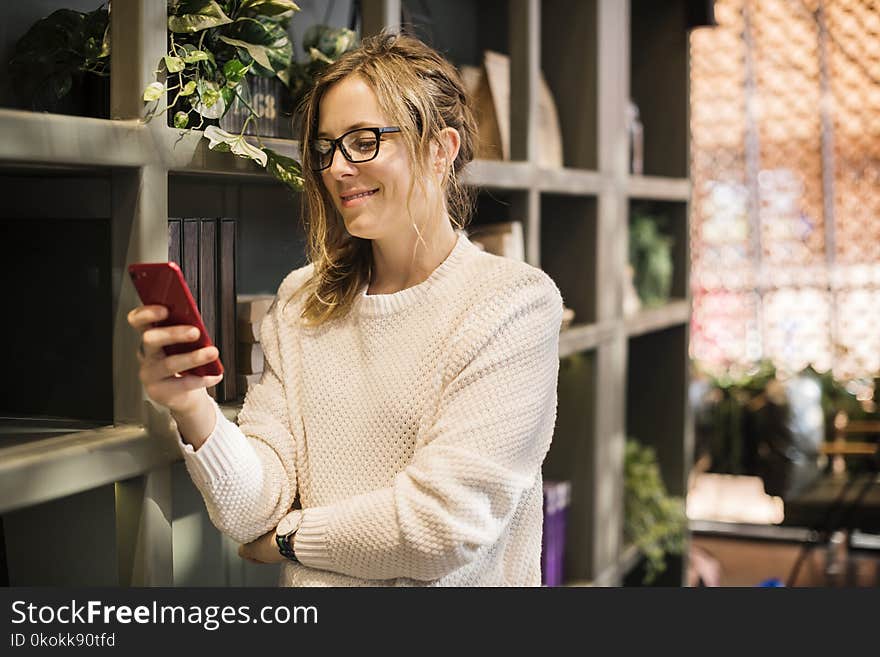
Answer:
624 438 687 584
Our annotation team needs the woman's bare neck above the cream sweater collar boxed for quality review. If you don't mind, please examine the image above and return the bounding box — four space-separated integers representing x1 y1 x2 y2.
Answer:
367 216 457 294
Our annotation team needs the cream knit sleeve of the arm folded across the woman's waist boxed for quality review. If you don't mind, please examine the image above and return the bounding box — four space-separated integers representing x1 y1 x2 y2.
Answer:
294 272 562 581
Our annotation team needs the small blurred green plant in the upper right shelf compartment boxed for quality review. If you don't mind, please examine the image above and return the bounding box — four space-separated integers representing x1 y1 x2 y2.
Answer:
629 215 673 307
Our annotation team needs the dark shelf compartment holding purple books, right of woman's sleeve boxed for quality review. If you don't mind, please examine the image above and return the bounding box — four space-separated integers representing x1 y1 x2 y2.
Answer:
543 351 597 581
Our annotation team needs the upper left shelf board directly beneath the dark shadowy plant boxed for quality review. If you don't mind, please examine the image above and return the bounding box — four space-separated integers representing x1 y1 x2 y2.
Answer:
0 109 152 167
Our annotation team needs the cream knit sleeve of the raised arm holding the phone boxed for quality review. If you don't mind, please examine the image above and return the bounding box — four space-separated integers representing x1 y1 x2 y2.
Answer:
177 292 299 543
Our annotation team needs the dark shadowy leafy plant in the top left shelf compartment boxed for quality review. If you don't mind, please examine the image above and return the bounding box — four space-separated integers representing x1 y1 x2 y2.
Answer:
9 4 110 112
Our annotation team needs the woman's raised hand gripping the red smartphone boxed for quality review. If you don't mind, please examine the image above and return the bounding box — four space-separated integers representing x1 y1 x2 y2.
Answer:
128 306 223 415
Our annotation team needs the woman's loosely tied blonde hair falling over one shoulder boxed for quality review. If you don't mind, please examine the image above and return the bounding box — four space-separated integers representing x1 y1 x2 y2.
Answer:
300 33 477 325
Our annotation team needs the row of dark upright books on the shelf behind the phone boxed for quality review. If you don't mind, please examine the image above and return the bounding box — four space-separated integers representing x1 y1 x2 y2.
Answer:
168 218 238 402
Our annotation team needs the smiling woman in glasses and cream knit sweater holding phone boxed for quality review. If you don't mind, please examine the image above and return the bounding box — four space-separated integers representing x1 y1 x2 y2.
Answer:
129 35 562 586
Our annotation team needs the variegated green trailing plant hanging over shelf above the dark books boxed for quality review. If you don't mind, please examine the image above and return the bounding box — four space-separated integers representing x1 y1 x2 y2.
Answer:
144 0 302 191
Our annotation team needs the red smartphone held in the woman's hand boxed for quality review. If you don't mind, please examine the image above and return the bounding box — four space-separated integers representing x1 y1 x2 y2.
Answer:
128 262 223 376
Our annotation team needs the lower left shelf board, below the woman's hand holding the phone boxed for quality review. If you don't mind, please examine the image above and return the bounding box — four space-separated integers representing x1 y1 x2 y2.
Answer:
0 425 164 513
